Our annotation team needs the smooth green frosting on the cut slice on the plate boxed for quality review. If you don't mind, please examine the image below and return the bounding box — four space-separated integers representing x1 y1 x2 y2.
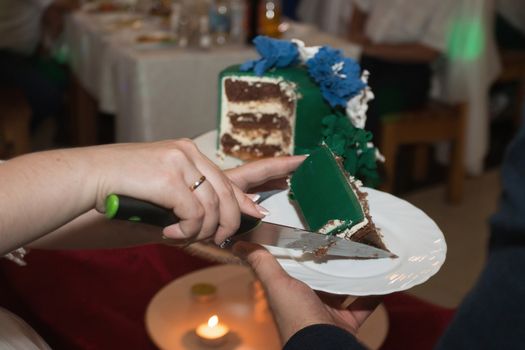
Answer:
290 144 365 234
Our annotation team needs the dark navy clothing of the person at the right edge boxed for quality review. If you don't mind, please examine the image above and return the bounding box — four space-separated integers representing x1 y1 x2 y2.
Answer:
438 122 525 349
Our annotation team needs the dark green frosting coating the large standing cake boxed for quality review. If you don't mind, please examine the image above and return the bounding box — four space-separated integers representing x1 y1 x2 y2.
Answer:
217 65 332 154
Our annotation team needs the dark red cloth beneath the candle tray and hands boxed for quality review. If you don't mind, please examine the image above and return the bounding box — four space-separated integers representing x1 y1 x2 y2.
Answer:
0 245 453 350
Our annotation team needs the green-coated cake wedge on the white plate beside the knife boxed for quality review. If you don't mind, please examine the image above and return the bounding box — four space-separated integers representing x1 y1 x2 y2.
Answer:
290 144 387 250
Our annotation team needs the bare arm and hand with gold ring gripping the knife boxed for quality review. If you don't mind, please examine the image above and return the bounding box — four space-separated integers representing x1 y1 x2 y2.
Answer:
0 140 270 255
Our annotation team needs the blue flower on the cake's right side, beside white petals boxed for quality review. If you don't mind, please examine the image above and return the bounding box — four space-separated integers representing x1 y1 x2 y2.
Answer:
306 46 366 107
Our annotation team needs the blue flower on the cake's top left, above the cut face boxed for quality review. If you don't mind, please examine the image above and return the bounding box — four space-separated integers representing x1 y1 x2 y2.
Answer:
240 36 299 76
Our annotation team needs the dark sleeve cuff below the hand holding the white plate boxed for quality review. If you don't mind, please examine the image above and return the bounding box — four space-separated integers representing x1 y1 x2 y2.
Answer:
283 324 365 350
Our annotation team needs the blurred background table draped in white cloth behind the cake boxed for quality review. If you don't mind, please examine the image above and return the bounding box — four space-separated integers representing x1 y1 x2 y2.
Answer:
65 11 360 144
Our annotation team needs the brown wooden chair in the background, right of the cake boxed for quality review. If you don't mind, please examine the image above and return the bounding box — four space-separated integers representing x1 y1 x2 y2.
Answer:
380 101 466 203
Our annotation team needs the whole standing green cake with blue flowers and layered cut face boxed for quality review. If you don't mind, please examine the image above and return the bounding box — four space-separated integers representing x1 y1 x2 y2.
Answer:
213 37 382 187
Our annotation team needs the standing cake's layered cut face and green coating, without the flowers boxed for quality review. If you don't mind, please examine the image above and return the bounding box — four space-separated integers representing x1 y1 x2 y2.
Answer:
218 66 330 160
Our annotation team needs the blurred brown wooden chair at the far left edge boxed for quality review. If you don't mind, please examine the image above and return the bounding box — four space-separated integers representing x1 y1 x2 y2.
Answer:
0 87 31 159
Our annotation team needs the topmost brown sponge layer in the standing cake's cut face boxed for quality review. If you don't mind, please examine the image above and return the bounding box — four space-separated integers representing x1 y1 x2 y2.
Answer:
224 79 295 111
